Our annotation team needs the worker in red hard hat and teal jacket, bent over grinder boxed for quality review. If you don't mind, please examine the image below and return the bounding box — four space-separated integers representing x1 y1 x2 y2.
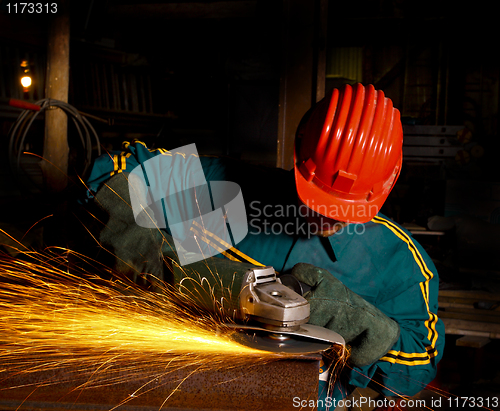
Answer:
83 84 444 409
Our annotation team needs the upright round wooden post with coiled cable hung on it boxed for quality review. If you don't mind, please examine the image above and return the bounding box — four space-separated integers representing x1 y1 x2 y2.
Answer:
41 0 70 192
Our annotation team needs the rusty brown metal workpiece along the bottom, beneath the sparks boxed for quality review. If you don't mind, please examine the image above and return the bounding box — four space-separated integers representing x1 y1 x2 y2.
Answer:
0 354 321 411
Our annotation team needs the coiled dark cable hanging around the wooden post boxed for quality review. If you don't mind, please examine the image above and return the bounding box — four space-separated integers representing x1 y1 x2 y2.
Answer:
8 98 101 191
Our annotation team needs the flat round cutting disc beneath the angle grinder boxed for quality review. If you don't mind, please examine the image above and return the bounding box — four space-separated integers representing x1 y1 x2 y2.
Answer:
231 328 332 354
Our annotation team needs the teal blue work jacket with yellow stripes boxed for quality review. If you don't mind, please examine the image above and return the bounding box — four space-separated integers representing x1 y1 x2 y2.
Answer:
88 142 445 402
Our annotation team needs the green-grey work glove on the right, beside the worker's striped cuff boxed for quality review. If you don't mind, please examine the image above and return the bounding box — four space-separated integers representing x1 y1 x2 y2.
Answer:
292 263 399 367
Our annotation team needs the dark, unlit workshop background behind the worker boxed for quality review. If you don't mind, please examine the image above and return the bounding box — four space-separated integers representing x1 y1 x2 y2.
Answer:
0 0 500 406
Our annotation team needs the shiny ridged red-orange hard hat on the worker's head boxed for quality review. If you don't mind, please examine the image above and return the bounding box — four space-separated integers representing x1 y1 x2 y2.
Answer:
295 84 403 223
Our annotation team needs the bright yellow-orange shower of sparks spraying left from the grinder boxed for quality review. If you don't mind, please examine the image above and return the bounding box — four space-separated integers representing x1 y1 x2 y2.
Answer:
0 243 290 408
